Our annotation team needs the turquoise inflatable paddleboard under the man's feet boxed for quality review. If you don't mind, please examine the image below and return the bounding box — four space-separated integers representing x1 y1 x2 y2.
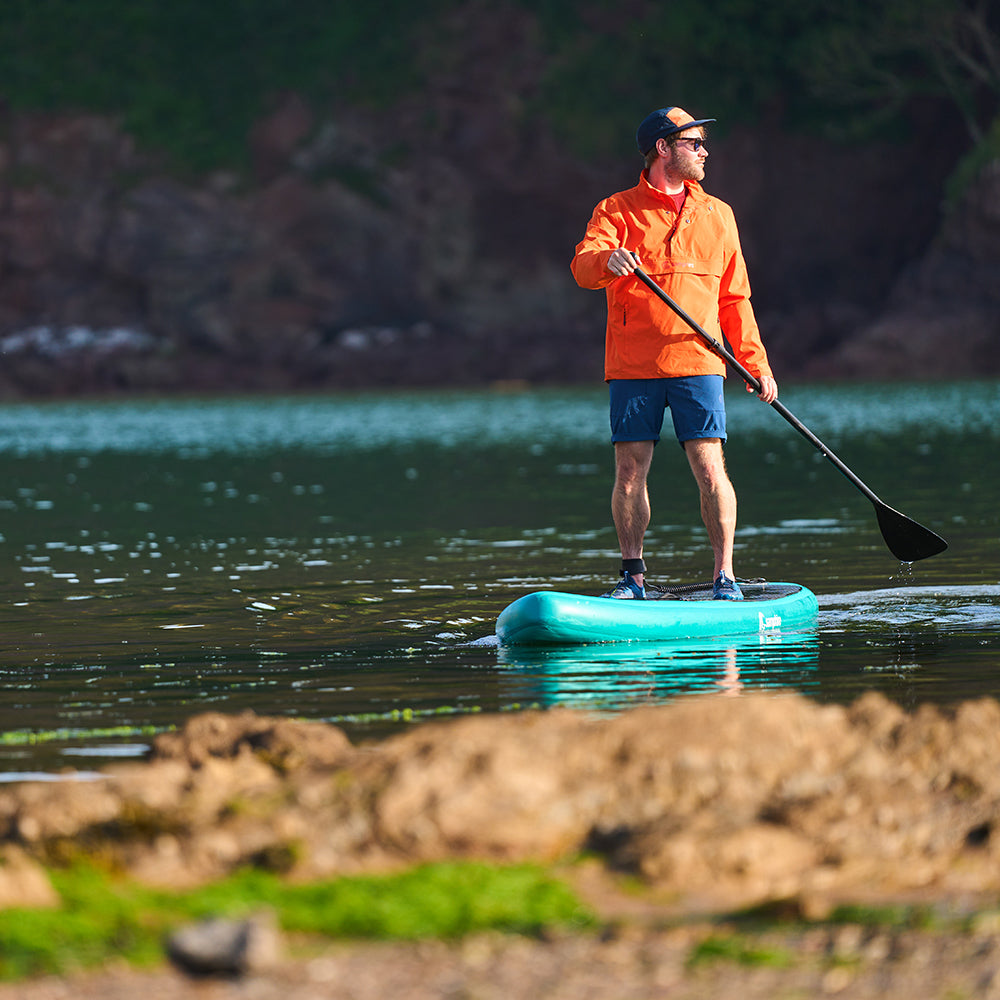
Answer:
496 580 817 645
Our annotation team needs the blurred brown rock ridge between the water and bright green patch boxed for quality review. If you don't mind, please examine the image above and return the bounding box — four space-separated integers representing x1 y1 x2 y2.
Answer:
0 694 1000 916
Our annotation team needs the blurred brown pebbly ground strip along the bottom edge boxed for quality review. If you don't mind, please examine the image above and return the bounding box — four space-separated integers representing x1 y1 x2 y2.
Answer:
0 925 1000 1000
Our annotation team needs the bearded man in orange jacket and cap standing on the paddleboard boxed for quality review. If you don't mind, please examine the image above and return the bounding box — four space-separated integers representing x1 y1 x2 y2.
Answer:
572 107 778 601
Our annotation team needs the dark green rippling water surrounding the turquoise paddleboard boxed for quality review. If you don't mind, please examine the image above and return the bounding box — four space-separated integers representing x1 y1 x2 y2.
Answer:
0 382 1000 780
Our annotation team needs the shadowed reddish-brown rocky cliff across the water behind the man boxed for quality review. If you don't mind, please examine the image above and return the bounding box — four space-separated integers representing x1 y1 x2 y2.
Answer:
0 93 1000 397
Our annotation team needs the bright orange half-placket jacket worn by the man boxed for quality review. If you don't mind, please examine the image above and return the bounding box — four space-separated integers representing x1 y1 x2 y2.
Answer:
571 171 771 380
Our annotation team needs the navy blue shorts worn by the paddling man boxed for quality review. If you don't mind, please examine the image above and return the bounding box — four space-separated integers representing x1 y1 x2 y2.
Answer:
608 375 726 444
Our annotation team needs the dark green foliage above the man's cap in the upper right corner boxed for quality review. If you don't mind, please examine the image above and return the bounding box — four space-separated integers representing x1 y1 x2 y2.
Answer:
543 0 1000 156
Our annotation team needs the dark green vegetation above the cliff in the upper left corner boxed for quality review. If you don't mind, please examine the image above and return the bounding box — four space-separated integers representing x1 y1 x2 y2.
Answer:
0 0 450 169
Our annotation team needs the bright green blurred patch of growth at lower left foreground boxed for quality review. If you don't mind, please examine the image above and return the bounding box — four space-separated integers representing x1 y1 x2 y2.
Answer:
0 862 594 979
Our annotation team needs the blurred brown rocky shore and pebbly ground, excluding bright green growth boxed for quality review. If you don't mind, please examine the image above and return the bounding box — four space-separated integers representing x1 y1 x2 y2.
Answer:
0 694 1000 1000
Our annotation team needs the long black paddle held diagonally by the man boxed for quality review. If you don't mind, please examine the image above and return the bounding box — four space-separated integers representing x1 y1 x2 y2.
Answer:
635 267 948 562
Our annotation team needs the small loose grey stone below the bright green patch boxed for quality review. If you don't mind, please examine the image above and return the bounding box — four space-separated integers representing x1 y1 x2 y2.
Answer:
166 913 281 976
